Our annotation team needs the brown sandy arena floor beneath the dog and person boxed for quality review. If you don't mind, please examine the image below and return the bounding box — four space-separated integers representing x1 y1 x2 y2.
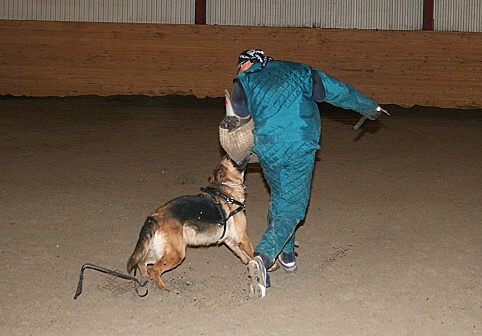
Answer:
0 97 482 336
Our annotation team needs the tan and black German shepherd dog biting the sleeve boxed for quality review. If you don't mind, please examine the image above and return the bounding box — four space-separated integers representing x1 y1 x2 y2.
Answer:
127 156 253 289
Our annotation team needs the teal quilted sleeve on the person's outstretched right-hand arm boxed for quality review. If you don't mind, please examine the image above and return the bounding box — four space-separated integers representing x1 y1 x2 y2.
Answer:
316 70 378 116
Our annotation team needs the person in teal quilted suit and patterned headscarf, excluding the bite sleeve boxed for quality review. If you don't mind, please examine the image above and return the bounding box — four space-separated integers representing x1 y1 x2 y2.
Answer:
231 49 388 297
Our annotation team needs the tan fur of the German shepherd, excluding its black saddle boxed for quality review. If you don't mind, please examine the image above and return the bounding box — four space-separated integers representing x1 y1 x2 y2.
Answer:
127 156 253 289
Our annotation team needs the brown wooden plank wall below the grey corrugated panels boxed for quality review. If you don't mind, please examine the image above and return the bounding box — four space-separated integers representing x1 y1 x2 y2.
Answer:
0 20 482 108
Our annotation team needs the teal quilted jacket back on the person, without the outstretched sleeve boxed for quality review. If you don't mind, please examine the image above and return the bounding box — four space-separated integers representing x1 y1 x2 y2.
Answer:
236 61 321 146
